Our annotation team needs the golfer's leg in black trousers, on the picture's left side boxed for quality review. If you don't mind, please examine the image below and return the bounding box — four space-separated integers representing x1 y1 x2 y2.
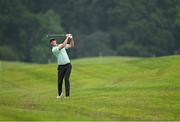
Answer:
58 66 65 96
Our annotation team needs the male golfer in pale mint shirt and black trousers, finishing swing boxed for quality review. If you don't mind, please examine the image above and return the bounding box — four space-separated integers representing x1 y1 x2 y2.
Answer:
50 34 74 99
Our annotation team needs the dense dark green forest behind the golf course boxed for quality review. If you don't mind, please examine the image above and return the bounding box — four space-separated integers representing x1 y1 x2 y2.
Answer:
0 0 180 63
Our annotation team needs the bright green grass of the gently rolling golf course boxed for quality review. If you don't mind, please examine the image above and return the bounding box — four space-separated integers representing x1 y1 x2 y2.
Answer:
0 56 180 121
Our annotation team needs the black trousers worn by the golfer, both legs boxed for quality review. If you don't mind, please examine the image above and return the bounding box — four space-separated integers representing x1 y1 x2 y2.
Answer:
58 63 72 96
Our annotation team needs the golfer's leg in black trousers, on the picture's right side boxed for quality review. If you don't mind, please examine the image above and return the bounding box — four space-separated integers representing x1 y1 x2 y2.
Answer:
65 64 72 97
